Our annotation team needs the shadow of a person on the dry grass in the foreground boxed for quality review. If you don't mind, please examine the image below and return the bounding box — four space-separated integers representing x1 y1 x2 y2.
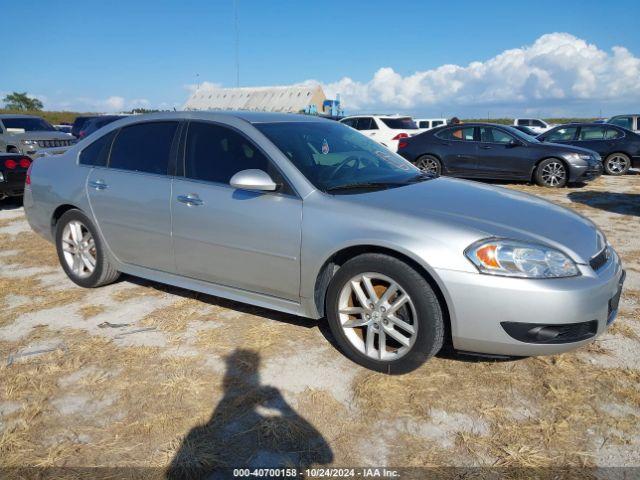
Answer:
166 349 333 480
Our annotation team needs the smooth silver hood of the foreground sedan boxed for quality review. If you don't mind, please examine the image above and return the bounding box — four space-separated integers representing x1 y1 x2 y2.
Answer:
343 177 606 263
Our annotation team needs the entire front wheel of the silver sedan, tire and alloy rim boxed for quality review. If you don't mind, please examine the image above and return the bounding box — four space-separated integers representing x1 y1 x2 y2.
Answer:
326 254 444 374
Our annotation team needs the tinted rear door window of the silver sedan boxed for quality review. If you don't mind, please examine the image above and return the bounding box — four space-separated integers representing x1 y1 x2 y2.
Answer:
109 122 178 175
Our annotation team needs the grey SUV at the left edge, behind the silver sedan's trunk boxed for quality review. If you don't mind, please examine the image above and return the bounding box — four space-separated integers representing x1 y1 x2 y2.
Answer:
0 114 73 157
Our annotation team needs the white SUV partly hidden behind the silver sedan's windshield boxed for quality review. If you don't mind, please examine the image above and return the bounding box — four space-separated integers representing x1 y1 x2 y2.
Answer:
340 115 420 152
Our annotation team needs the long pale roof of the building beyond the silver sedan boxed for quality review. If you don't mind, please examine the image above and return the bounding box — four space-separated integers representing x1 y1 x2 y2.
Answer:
184 85 326 113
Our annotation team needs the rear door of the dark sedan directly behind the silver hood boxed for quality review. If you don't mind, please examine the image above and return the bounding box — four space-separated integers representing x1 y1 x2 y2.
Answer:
435 126 478 177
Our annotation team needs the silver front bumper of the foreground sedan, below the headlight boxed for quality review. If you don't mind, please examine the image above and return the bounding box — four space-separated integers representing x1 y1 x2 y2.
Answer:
436 248 624 356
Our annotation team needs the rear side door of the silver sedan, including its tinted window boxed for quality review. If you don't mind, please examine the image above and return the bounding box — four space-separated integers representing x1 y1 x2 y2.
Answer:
87 121 178 272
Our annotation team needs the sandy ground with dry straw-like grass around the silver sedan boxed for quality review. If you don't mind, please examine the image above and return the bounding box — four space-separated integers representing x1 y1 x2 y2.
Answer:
0 172 640 477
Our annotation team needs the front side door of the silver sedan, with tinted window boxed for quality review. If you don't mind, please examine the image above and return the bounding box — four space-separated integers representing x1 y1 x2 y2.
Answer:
171 122 302 300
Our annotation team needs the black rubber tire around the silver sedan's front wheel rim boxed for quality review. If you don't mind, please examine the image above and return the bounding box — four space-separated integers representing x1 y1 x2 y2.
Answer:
326 253 445 374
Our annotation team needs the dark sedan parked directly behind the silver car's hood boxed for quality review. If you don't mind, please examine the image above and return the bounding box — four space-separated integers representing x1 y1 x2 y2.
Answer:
398 123 602 187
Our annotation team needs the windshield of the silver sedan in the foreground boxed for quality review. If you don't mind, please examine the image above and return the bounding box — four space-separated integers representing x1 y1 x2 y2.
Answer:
254 122 421 192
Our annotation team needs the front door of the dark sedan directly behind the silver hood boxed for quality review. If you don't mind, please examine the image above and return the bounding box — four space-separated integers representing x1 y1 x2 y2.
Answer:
476 127 532 179
